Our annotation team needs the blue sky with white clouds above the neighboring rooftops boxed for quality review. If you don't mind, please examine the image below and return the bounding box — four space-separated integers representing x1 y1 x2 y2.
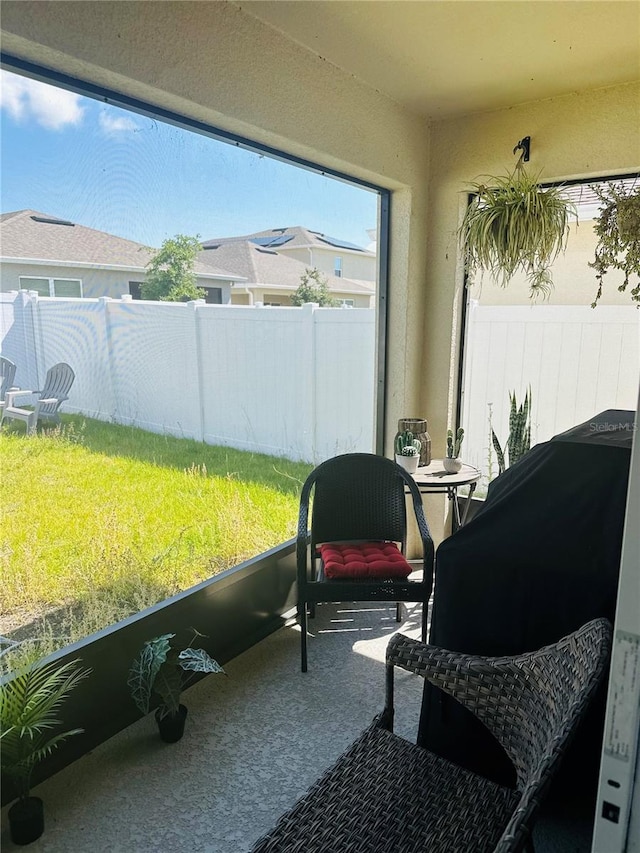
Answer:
0 71 377 246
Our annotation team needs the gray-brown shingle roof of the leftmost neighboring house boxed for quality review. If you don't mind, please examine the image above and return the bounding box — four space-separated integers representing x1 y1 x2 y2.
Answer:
0 210 237 279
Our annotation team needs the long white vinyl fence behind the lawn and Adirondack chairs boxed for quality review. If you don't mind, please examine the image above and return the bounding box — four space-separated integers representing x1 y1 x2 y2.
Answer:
0 291 376 464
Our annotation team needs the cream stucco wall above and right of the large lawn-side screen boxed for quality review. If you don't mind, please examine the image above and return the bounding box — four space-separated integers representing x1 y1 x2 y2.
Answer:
2 0 432 460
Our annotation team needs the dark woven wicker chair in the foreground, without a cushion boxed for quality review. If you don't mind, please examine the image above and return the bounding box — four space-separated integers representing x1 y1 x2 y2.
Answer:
252 619 611 853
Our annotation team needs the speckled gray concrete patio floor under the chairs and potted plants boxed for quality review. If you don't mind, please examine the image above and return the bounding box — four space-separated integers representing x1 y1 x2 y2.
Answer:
1 604 590 853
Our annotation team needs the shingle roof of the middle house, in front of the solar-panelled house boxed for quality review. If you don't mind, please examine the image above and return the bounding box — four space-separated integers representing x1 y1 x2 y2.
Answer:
198 240 375 295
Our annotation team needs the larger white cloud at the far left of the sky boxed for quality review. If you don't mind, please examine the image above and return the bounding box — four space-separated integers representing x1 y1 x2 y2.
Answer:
0 71 84 130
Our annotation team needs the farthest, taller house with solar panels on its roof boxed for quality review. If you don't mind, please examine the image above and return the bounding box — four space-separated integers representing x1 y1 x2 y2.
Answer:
202 226 378 282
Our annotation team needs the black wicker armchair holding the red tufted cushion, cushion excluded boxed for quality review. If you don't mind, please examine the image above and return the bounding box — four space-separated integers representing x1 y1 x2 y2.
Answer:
297 453 434 672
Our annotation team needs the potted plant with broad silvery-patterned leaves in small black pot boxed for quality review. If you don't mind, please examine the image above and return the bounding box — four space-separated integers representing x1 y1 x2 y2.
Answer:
127 629 224 743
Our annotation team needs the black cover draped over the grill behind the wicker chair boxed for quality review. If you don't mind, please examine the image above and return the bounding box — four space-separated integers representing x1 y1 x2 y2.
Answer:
418 410 635 797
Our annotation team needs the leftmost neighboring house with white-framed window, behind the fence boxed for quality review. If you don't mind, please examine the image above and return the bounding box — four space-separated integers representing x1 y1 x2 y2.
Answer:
0 210 241 303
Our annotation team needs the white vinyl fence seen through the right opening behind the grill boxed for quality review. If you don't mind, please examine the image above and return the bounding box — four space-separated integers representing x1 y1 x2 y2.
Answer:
461 304 640 485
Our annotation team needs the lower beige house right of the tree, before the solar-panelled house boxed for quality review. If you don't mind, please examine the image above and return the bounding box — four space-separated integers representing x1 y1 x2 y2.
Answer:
198 240 375 308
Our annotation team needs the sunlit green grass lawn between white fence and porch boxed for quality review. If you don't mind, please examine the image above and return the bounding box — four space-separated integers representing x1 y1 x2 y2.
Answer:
0 415 312 646
